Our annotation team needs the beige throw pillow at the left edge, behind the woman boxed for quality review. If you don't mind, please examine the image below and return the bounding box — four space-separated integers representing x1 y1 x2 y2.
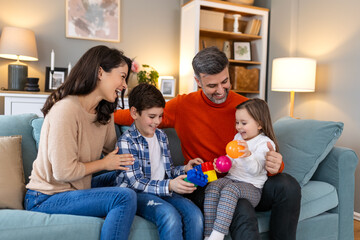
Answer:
0 136 25 209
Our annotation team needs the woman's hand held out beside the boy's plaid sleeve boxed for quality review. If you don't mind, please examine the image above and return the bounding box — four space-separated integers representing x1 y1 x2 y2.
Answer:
102 147 135 171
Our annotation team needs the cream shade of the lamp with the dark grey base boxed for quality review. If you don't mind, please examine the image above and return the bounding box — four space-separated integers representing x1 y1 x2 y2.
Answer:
0 27 38 61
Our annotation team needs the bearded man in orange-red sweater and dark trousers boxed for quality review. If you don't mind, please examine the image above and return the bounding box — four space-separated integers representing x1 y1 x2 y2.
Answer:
115 47 301 240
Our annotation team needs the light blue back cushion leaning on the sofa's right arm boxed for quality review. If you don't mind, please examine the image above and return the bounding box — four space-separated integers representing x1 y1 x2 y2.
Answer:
274 117 344 186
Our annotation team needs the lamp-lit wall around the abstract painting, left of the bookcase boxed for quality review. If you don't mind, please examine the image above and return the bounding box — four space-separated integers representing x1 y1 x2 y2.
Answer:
0 0 181 113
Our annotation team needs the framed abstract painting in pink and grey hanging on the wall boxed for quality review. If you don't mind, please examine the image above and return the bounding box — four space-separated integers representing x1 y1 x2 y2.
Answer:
65 0 120 42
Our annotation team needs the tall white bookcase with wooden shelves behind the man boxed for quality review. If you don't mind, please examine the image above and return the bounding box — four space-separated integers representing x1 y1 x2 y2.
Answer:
179 0 269 99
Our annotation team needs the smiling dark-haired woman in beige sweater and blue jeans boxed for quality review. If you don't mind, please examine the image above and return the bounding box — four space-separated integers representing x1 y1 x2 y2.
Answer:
24 46 136 239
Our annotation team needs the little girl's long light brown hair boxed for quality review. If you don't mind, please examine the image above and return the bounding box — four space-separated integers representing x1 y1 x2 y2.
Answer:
236 98 279 152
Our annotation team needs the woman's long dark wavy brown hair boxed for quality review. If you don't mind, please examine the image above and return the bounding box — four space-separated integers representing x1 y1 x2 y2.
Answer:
41 45 132 125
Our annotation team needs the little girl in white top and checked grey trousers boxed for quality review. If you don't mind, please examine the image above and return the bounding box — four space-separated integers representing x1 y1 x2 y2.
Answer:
204 98 278 240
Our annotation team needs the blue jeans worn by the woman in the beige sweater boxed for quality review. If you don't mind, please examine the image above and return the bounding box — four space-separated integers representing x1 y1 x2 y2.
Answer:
24 174 136 240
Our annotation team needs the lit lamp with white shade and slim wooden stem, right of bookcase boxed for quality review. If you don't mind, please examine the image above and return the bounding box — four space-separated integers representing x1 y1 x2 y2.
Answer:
271 57 316 117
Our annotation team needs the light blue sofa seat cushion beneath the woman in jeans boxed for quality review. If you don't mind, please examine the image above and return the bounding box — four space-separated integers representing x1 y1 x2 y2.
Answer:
0 210 104 240
